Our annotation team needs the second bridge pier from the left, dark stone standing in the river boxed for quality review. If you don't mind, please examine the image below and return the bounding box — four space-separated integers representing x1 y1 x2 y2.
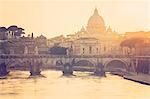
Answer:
30 61 41 76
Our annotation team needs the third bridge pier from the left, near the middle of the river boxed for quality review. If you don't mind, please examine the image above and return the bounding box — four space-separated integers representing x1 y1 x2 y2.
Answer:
62 63 73 75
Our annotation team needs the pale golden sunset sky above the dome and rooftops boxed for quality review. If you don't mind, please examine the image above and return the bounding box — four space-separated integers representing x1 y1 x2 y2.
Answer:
0 0 150 38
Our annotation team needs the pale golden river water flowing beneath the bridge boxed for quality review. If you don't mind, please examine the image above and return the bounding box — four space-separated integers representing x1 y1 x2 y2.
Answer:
0 71 150 99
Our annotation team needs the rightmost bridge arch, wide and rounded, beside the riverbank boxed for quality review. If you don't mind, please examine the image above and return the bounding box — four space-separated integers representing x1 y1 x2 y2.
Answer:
104 59 128 71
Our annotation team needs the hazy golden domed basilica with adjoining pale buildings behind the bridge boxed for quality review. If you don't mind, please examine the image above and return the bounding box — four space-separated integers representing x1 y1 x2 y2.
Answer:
49 8 123 55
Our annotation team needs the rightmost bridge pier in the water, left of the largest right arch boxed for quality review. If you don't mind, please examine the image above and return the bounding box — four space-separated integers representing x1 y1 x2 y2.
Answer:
94 64 106 77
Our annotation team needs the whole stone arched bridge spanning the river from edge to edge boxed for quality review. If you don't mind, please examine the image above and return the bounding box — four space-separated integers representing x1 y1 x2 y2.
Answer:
0 54 150 74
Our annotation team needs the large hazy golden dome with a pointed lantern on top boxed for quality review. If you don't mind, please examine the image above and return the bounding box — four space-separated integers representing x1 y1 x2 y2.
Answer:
87 8 105 33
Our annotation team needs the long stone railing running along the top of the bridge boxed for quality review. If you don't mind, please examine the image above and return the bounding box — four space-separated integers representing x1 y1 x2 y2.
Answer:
0 54 134 58
